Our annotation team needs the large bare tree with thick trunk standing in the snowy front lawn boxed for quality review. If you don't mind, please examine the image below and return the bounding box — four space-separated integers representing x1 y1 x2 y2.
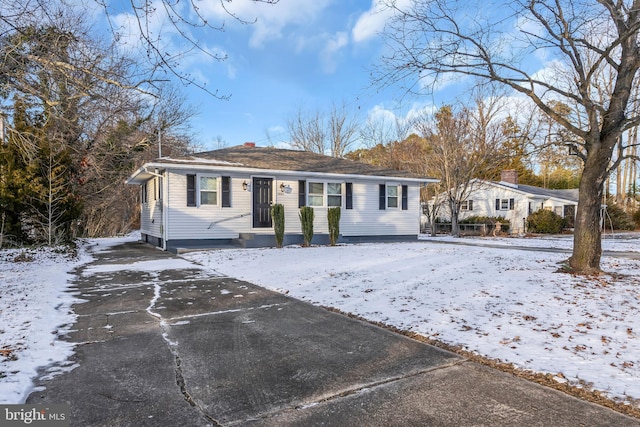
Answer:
379 0 640 274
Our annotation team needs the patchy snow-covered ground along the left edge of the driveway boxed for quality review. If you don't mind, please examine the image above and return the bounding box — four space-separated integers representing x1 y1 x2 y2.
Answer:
0 233 140 404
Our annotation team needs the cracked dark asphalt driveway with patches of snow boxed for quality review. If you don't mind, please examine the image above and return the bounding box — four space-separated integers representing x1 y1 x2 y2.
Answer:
26 243 640 426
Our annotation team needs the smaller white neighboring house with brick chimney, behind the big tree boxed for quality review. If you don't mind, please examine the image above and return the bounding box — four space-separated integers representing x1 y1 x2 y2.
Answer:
438 170 578 234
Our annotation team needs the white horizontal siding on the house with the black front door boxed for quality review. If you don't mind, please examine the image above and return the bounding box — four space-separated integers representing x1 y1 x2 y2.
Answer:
141 170 420 244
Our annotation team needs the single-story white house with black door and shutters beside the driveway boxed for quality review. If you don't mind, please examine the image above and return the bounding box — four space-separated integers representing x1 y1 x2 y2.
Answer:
127 143 437 252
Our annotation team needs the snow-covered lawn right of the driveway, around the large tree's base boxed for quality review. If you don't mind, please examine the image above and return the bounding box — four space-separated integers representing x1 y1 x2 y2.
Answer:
185 235 640 406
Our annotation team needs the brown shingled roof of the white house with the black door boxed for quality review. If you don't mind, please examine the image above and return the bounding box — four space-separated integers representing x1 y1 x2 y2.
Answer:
153 144 433 181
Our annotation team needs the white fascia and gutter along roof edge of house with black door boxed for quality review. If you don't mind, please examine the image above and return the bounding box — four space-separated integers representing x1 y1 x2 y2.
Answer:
126 163 440 184
